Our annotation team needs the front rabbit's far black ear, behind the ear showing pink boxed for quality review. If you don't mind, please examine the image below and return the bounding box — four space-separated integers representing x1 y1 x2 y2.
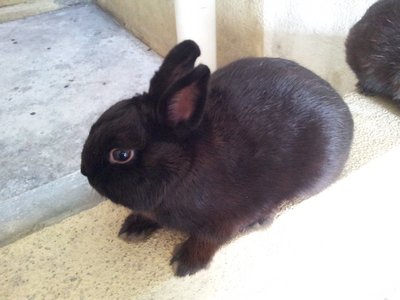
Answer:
149 40 200 97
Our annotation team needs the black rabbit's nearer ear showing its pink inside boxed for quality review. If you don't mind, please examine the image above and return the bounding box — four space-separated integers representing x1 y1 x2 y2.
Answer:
157 65 210 130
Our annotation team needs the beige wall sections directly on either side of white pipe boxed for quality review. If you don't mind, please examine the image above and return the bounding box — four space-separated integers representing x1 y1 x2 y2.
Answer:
97 0 263 66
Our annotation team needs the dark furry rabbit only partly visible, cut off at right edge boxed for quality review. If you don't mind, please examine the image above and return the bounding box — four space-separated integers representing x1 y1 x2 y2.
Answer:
346 0 400 104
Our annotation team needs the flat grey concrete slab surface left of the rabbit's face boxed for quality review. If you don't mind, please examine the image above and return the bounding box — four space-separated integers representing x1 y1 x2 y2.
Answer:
0 5 160 244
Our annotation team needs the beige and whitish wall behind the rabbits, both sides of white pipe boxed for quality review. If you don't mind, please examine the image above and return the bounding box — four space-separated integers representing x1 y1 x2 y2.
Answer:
98 0 376 94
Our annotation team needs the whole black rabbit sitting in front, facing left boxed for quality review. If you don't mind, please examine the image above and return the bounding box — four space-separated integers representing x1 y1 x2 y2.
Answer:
81 40 353 276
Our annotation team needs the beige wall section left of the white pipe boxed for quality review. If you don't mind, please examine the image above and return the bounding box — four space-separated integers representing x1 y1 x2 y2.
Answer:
97 0 176 55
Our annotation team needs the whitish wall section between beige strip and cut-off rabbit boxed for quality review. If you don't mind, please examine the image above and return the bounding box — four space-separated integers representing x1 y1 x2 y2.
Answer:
263 0 375 94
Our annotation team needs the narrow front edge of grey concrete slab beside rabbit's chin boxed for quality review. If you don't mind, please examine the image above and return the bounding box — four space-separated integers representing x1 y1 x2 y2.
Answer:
0 172 103 247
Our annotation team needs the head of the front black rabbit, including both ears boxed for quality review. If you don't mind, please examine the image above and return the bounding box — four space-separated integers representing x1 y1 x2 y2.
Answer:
81 40 210 211
